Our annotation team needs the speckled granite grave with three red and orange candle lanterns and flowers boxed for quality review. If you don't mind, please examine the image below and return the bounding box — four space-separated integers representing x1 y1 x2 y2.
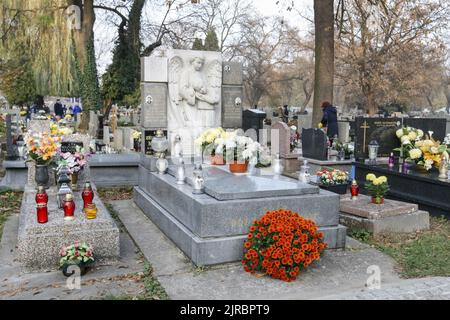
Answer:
7 119 120 276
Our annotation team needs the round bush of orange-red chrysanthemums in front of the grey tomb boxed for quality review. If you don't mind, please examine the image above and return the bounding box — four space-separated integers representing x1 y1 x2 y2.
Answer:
242 209 327 282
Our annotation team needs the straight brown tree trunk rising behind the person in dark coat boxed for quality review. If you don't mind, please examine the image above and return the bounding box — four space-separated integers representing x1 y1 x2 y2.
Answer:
312 0 334 127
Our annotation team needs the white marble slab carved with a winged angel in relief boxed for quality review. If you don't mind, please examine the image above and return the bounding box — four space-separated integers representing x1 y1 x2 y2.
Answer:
167 50 222 155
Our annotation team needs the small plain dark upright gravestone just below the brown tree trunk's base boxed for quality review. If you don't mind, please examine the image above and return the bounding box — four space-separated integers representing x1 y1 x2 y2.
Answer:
302 128 328 161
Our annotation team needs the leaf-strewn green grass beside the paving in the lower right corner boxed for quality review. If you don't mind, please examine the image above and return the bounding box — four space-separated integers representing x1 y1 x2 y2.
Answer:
349 217 450 278
